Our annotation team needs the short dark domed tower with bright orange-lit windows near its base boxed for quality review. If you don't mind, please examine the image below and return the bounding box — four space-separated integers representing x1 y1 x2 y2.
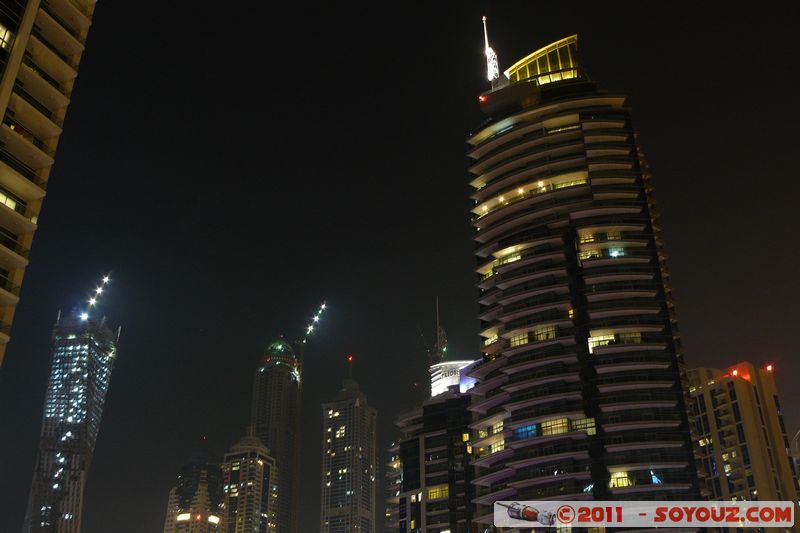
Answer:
164 452 225 533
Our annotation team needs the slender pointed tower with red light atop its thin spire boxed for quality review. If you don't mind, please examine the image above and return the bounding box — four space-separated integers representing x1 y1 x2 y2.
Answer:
320 379 378 533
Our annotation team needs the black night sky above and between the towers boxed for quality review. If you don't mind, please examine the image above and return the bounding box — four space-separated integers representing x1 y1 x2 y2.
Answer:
0 0 800 533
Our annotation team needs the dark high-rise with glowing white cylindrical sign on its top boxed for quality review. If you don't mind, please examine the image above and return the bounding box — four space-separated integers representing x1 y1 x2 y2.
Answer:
387 361 475 533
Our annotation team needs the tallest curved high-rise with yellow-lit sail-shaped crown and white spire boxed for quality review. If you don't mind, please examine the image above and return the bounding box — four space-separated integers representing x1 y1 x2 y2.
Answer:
467 35 698 524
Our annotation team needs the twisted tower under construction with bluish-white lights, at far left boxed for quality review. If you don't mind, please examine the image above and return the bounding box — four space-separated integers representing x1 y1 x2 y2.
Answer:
23 314 118 533
